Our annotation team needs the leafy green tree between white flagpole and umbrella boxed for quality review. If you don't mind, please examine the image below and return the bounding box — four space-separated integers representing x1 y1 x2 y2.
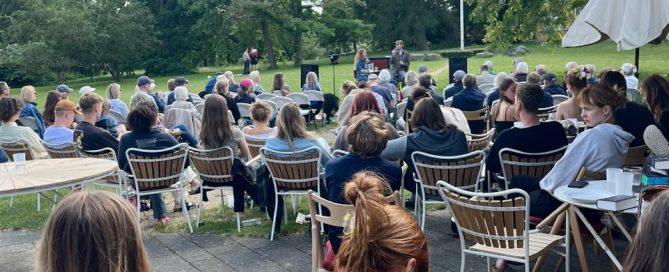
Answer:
467 0 587 49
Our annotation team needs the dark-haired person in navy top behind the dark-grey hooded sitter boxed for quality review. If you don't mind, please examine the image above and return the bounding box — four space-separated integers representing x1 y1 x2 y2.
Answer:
451 74 485 134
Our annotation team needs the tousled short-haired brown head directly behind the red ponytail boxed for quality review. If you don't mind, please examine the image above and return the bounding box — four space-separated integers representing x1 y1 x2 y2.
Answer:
344 111 390 157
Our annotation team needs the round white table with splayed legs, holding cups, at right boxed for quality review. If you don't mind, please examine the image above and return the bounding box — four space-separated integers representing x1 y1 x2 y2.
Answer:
553 180 639 271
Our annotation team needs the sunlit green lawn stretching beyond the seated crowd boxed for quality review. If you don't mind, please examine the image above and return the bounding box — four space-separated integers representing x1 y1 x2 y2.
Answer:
19 42 669 105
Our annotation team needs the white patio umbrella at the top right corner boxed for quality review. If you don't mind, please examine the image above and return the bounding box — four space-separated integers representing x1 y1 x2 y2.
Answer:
562 0 669 72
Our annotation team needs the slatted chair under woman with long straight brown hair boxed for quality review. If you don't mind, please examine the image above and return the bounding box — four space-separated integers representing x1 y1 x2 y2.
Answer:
188 146 241 232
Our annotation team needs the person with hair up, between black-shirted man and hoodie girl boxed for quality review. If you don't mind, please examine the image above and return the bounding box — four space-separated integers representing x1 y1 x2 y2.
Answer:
555 66 588 121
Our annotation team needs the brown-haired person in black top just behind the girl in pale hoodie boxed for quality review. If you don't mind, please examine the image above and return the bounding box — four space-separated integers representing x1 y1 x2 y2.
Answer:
599 71 655 147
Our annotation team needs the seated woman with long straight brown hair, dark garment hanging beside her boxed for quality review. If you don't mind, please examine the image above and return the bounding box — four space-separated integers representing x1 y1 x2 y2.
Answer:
200 95 258 208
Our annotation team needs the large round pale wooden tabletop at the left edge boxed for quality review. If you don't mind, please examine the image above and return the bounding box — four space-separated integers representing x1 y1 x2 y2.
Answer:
0 158 118 197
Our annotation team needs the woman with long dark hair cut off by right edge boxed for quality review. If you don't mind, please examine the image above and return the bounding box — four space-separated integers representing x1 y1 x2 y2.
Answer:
640 75 669 156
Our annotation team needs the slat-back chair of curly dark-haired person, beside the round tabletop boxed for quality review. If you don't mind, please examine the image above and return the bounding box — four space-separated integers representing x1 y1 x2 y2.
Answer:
125 144 193 233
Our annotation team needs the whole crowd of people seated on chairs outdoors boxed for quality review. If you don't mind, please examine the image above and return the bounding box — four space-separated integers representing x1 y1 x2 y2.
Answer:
0 52 669 271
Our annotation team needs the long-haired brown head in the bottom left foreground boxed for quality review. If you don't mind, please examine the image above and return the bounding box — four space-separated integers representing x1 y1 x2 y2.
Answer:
36 191 150 272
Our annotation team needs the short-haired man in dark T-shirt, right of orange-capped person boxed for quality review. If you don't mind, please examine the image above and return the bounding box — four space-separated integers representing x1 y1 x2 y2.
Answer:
74 92 118 152
